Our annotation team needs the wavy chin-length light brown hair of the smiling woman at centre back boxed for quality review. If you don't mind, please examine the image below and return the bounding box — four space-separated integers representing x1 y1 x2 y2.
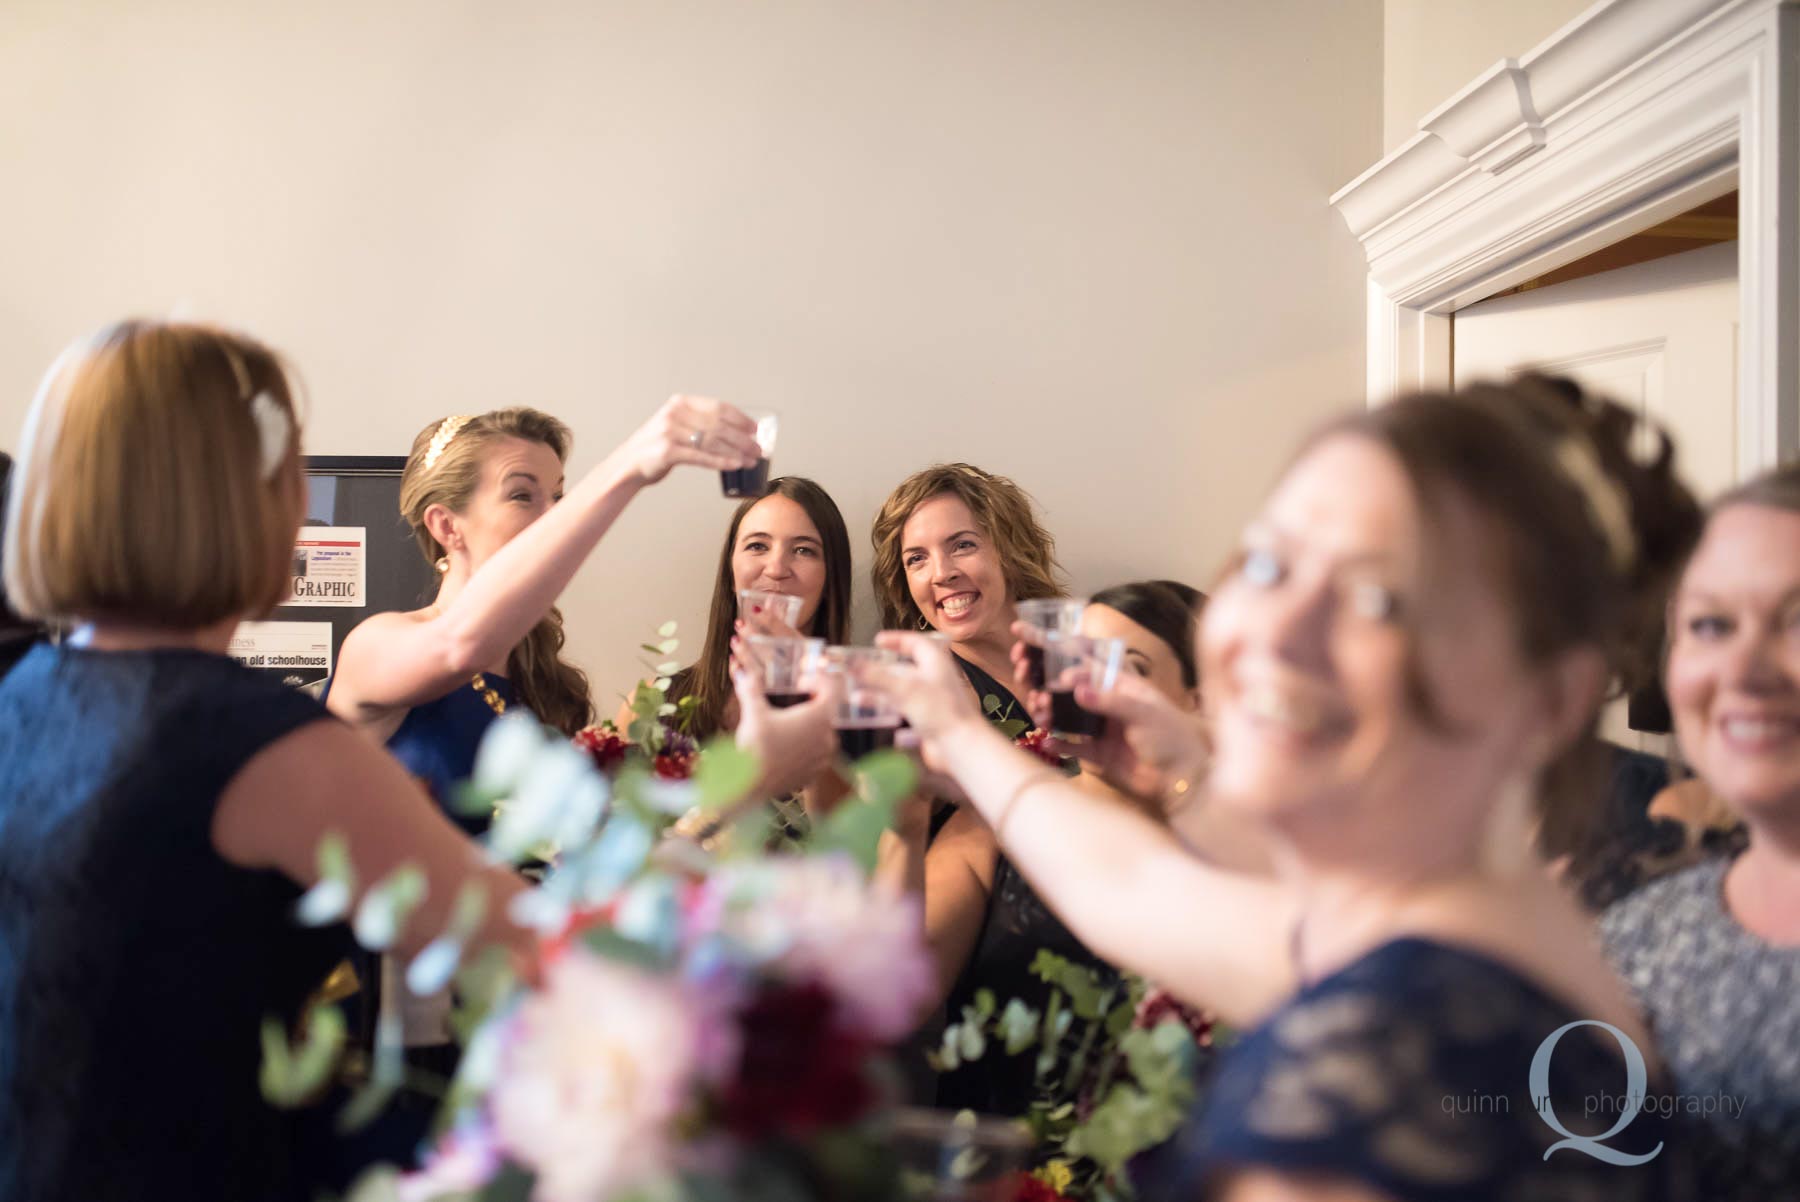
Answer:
869 462 1067 630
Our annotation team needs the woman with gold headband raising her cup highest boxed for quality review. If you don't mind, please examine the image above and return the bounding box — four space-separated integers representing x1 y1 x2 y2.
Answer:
328 396 760 833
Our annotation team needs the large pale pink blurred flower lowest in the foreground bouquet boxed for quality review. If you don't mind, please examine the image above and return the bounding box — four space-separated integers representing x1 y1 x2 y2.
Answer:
490 946 700 1202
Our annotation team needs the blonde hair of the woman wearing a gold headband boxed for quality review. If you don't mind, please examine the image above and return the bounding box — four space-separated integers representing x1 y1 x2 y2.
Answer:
400 408 594 734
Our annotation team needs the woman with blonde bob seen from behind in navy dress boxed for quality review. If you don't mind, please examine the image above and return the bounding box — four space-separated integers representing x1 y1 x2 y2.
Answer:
0 322 531 1202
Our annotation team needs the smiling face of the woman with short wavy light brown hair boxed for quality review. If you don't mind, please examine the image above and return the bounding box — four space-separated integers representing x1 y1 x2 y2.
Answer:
900 493 1013 642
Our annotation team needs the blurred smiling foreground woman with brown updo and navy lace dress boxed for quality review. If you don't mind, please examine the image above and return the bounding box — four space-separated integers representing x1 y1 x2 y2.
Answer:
882 378 1699 1202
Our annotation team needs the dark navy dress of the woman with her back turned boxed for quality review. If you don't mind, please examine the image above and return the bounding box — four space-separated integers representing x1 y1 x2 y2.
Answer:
0 646 349 1202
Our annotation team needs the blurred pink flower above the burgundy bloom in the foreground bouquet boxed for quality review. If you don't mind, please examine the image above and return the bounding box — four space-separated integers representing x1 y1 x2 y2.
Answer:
689 855 934 1042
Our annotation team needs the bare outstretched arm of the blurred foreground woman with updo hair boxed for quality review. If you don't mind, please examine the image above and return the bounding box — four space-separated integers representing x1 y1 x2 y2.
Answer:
882 633 1294 1024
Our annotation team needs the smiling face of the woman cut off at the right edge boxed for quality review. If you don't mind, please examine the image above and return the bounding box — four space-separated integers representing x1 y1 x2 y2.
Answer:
1669 504 1800 821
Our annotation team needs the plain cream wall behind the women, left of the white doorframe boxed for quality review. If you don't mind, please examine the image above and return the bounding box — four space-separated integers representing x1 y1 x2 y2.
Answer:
0 0 1391 708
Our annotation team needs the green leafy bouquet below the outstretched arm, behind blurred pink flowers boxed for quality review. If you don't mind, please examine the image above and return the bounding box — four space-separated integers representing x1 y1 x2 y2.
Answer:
931 950 1222 1202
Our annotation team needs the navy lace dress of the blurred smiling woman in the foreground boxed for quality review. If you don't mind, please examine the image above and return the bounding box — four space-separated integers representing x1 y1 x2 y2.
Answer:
1170 937 1694 1202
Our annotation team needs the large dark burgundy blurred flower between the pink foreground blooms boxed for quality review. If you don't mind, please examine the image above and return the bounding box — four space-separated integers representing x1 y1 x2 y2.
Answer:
720 984 875 1139
